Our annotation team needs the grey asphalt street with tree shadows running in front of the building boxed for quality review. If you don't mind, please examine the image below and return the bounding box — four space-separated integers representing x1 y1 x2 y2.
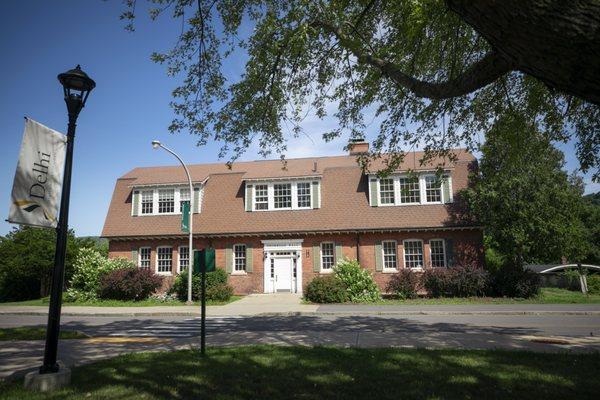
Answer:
0 314 600 338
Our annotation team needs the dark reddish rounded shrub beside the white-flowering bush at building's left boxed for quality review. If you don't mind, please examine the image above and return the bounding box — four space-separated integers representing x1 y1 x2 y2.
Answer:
98 268 162 301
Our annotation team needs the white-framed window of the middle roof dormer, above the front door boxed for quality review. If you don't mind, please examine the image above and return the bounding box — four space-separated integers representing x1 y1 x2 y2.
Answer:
246 180 320 211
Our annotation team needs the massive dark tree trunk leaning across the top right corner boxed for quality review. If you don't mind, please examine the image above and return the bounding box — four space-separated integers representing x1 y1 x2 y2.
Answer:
446 0 600 105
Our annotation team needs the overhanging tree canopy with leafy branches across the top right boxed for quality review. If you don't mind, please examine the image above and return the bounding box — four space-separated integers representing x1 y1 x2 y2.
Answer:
122 0 600 179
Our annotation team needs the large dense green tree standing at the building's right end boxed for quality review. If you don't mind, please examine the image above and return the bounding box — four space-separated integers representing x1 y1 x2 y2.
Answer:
465 117 589 265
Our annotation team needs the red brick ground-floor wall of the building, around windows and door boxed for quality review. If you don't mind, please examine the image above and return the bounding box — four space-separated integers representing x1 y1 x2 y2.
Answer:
109 228 483 294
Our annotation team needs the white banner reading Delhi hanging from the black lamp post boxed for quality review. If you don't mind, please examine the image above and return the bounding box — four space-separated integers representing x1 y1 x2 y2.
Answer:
8 118 67 228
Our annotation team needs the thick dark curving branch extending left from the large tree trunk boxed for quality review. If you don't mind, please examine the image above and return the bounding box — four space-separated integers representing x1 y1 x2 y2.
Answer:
313 21 513 99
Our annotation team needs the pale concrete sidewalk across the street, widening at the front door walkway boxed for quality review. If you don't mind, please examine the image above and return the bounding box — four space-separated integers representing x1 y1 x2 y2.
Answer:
0 293 600 317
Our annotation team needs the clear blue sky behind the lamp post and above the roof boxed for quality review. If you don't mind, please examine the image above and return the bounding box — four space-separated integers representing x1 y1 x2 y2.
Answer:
0 0 600 236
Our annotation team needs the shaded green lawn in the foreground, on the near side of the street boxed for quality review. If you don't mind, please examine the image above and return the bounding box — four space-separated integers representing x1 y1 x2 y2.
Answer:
0 346 600 400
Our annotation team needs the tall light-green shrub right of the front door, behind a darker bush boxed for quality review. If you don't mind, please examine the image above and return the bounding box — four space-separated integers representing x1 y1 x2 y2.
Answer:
333 260 381 302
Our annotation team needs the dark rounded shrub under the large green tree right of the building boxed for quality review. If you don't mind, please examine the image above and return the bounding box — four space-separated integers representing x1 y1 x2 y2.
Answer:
492 265 541 299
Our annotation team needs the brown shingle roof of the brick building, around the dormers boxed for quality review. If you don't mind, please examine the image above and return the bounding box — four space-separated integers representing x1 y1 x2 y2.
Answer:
102 150 474 237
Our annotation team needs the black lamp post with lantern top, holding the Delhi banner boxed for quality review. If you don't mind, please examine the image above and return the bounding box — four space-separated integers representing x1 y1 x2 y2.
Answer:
40 65 96 374
